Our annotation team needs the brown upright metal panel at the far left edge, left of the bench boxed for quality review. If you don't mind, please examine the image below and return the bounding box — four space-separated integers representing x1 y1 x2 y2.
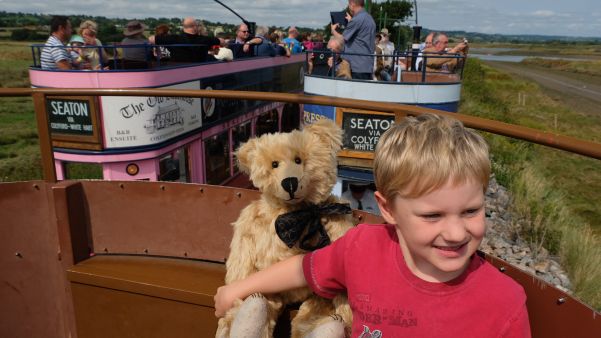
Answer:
0 181 75 337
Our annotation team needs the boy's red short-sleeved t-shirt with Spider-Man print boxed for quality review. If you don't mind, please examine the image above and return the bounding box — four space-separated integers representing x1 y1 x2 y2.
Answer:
303 224 530 338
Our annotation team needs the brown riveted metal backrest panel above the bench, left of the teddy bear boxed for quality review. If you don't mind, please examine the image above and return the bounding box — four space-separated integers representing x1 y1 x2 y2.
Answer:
82 181 259 262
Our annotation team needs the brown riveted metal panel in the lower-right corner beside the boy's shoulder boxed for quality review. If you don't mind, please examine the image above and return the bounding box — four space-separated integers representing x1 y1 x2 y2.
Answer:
486 255 601 338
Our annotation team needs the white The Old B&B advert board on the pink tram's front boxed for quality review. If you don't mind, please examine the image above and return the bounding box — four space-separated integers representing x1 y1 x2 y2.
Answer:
102 81 202 148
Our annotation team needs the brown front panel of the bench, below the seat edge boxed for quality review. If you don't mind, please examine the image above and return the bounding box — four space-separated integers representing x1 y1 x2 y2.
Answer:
71 283 217 338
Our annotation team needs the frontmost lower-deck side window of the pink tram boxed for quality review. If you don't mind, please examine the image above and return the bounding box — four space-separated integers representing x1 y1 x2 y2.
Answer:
204 132 230 184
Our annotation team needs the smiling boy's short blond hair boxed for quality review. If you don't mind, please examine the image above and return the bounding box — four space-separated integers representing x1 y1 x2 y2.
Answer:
374 114 490 200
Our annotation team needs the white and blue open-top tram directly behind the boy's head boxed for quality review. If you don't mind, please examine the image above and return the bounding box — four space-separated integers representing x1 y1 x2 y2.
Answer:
303 50 466 199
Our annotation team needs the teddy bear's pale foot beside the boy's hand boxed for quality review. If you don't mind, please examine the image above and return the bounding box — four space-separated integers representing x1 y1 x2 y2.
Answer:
230 293 268 338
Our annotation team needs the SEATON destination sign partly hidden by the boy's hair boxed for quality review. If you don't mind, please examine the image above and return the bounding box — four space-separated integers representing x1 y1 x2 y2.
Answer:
342 111 394 152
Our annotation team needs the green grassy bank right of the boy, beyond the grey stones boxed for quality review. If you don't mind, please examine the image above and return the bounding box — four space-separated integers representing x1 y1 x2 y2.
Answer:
460 59 601 309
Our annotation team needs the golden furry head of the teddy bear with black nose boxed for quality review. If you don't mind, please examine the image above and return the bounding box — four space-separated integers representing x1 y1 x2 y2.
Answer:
236 119 342 205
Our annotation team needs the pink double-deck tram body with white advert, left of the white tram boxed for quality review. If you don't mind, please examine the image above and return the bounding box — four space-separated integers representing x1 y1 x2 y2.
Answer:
29 55 305 186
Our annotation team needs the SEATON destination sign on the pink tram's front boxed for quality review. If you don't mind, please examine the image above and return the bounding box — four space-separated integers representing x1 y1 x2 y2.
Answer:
46 98 94 136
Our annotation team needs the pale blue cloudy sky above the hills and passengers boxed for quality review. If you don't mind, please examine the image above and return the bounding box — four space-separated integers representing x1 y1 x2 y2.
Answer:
0 0 601 37
